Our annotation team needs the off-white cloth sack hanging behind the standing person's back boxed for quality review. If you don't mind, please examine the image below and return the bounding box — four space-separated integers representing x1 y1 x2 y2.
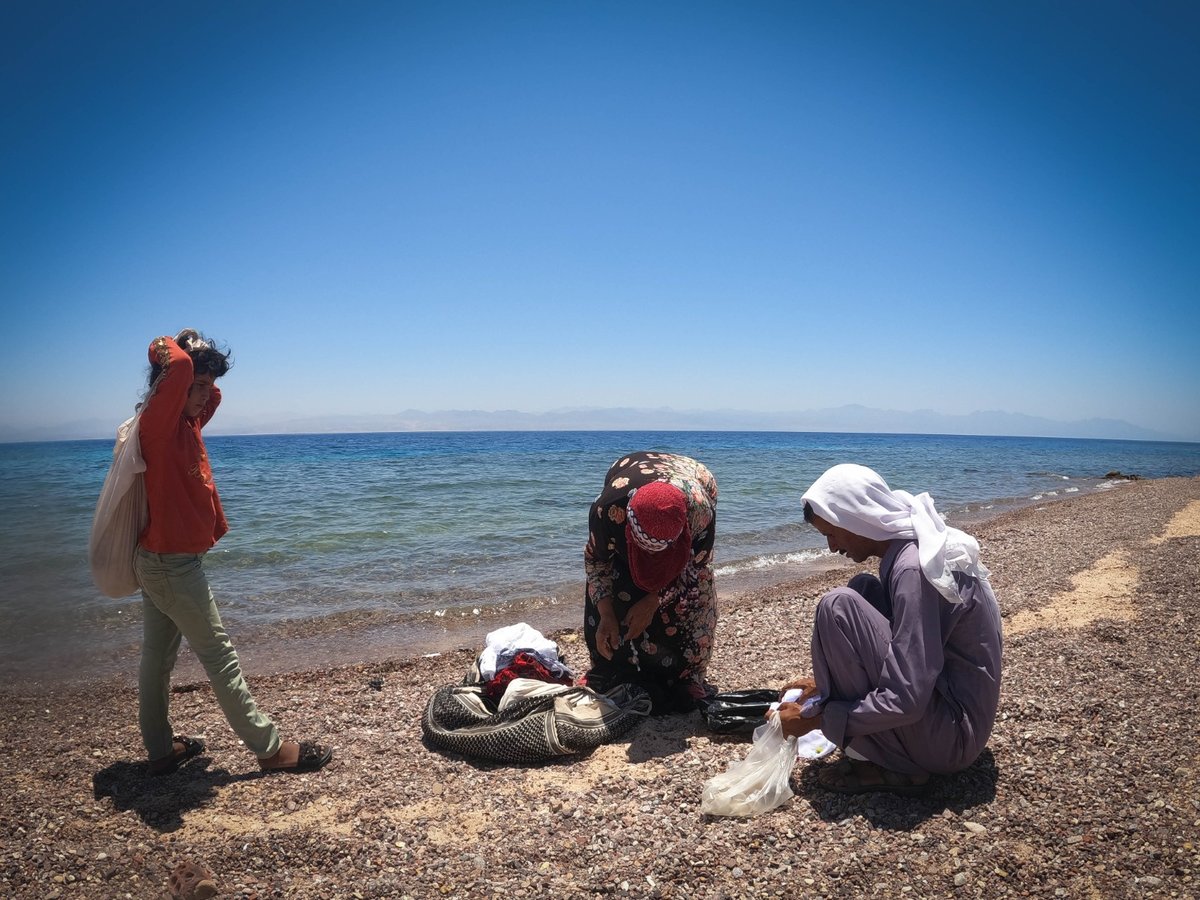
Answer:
88 415 150 598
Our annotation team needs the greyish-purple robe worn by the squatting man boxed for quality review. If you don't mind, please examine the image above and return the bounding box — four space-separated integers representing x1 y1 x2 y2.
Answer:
812 540 1001 775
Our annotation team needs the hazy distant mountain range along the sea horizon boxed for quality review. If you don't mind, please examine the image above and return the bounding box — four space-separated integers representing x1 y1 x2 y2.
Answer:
7 404 1196 442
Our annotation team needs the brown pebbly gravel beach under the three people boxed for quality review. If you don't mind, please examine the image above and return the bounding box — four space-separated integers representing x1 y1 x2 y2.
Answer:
0 478 1200 900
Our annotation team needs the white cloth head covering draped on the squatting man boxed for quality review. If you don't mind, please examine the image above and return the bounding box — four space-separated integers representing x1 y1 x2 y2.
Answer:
802 463 990 604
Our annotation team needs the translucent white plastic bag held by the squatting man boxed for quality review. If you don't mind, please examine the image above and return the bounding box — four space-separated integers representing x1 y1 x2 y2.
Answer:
700 715 796 816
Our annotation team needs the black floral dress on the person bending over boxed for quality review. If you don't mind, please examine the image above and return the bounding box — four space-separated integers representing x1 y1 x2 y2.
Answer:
583 451 716 709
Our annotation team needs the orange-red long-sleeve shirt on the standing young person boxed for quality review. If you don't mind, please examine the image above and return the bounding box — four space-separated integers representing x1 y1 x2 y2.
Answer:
138 337 229 553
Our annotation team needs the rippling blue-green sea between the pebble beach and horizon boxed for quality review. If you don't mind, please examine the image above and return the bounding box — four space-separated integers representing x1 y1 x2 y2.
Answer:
0 432 1200 678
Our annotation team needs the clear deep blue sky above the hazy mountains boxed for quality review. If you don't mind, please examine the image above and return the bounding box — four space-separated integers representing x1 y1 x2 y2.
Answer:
0 0 1200 439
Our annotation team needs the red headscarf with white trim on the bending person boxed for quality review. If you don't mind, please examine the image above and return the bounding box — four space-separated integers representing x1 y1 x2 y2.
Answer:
625 481 691 594
